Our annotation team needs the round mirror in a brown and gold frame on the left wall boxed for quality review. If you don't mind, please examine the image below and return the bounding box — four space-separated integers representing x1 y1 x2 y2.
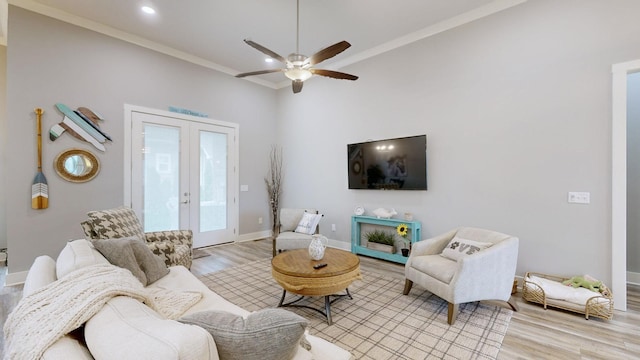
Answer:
53 149 100 182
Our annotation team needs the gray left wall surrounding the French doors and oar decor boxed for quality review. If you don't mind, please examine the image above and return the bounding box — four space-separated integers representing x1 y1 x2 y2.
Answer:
2 6 276 273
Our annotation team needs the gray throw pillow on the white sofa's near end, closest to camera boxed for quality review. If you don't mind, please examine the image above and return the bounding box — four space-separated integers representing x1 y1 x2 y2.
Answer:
178 309 311 360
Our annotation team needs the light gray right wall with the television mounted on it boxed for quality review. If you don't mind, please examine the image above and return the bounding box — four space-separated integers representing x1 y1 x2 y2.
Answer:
278 0 640 282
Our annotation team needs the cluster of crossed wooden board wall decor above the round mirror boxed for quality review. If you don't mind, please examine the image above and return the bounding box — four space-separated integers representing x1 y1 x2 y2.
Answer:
49 103 111 152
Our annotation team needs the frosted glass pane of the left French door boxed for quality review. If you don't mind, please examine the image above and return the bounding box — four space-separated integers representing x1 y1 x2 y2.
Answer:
142 124 180 231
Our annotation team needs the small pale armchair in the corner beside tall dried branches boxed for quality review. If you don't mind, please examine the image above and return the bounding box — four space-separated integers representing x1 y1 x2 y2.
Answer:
273 208 322 256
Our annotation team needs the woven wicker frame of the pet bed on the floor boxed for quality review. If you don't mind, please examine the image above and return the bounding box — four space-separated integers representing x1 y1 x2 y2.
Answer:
522 272 613 320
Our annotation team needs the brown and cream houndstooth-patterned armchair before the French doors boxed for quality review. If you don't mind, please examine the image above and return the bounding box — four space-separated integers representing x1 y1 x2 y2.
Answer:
81 207 193 269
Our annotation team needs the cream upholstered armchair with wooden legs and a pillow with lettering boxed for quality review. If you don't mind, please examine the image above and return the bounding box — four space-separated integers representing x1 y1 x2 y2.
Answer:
404 227 518 325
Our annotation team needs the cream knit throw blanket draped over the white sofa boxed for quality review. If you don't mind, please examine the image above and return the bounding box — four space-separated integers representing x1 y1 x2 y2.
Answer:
4 264 202 360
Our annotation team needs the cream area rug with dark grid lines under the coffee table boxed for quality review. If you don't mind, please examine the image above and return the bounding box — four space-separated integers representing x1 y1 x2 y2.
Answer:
200 259 512 360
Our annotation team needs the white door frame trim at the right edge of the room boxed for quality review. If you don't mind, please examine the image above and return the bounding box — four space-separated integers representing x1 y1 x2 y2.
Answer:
611 60 640 311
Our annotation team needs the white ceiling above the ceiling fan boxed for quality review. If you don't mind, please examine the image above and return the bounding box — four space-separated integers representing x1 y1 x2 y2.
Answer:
0 0 526 88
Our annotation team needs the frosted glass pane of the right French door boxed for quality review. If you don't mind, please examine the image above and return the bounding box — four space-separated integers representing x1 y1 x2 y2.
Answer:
200 131 227 232
